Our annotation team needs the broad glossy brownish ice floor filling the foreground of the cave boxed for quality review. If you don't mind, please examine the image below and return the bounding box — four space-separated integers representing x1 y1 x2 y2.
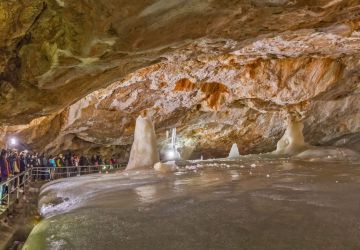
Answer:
24 159 360 250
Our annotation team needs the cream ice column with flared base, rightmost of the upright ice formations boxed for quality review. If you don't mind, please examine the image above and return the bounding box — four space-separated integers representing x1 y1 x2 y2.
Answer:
274 119 308 155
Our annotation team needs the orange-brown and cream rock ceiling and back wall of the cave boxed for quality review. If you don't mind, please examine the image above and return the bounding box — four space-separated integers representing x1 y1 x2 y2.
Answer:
0 0 360 158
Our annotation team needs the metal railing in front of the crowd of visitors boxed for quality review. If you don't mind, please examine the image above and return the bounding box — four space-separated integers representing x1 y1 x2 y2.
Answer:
0 164 124 215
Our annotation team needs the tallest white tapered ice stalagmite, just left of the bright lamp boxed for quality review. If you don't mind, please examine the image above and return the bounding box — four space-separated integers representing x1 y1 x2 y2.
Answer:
126 116 160 170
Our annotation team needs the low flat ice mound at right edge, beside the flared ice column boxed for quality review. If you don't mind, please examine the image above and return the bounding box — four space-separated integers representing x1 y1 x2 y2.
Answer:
296 147 360 161
